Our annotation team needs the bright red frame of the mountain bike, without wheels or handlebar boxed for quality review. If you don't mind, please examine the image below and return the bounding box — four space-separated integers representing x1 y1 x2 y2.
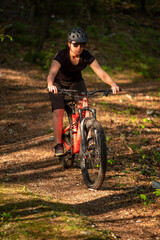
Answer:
62 97 89 154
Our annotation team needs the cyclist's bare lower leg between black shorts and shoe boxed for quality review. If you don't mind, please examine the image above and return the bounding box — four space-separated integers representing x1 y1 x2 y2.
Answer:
52 109 64 145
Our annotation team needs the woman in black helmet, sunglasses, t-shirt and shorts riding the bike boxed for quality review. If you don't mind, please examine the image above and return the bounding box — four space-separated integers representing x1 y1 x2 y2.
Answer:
47 28 119 156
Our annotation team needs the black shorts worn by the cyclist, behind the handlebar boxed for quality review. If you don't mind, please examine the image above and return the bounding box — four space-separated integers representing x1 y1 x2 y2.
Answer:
49 79 87 112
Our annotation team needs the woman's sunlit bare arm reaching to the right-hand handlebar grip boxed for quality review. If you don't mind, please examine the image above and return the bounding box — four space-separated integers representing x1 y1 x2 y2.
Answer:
90 60 119 93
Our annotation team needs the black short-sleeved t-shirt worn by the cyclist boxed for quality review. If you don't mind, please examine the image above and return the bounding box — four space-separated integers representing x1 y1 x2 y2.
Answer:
54 47 95 86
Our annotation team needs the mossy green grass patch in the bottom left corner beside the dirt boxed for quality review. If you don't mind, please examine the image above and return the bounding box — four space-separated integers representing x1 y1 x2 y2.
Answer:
0 184 111 240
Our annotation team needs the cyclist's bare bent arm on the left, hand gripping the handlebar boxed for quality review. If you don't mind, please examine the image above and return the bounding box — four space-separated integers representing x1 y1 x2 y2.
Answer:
47 60 61 93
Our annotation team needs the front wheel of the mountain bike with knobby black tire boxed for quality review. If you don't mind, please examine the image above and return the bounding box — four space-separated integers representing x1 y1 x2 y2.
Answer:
80 118 107 189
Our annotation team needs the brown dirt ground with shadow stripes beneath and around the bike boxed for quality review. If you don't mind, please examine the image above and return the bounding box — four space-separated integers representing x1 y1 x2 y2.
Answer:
0 64 160 240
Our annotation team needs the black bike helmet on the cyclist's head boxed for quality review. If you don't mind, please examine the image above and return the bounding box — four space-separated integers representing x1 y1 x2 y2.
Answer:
68 28 88 42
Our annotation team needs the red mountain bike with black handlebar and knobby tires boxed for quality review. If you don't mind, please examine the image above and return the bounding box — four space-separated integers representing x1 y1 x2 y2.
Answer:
58 89 112 189
